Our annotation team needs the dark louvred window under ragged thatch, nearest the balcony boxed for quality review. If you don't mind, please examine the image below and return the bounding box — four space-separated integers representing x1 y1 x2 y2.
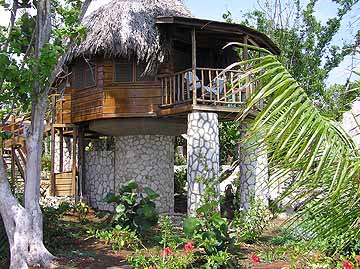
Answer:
114 60 155 83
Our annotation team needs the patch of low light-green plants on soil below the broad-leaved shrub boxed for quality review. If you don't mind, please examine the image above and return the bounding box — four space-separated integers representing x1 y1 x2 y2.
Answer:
88 225 141 251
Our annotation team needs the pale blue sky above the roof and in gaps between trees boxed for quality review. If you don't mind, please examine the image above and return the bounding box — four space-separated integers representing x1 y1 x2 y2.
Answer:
0 0 360 85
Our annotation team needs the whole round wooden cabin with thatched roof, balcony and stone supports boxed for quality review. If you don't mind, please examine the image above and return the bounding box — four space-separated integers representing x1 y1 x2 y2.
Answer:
2 0 280 212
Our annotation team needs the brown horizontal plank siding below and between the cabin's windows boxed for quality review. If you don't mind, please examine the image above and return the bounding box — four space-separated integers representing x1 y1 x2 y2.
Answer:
67 61 161 123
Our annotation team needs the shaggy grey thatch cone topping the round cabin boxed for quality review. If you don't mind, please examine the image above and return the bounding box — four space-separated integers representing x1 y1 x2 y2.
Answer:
73 0 192 70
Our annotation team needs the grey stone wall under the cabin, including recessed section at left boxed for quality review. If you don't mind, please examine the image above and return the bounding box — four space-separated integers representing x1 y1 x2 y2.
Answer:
85 135 174 213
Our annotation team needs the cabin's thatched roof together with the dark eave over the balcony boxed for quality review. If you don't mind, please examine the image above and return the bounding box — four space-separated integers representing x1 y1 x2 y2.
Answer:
71 0 280 73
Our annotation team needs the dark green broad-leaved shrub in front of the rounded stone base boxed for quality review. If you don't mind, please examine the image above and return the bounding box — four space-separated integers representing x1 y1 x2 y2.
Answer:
104 181 159 233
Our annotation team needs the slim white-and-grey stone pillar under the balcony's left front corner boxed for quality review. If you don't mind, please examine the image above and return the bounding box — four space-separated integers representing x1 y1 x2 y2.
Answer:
187 112 219 214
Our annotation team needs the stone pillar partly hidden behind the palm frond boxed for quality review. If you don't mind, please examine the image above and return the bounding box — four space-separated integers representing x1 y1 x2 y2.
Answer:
239 122 269 210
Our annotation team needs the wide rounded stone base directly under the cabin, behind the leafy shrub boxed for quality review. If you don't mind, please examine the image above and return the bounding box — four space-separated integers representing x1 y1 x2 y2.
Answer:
115 135 175 213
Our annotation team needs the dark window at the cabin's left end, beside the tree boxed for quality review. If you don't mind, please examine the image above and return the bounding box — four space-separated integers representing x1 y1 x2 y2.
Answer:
72 62 96 89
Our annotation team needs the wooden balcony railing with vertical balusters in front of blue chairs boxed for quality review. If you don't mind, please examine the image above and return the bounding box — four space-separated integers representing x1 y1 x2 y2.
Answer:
160 68 252 107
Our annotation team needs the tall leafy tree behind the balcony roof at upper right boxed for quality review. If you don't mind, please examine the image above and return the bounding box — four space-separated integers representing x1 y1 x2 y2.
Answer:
223 0 359 119
